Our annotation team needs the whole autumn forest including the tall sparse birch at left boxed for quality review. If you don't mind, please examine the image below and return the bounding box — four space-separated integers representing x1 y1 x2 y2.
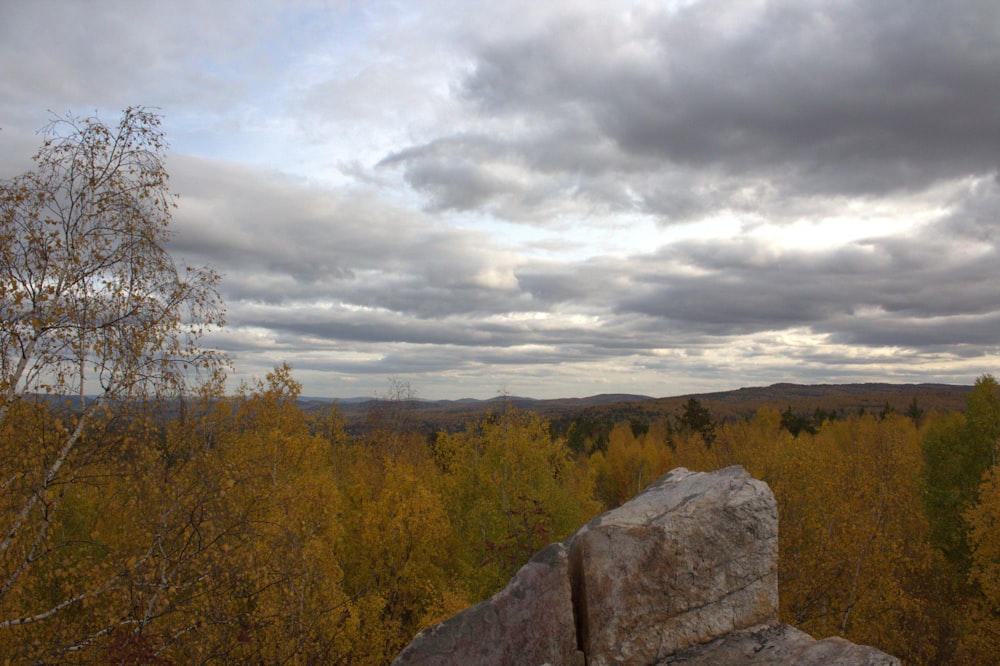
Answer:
0 108 1000 665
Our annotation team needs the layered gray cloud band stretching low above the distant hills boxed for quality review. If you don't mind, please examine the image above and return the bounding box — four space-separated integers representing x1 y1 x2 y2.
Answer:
168 141 1000 390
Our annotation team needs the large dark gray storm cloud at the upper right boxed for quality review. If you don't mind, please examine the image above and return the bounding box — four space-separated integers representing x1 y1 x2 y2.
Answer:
386 0 1000 220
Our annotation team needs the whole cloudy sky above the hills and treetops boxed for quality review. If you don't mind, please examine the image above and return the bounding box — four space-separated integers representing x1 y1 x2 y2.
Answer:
0 0 1000 399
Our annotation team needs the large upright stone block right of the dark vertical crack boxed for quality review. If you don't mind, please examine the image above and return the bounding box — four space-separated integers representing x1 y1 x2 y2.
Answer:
572 467 778 666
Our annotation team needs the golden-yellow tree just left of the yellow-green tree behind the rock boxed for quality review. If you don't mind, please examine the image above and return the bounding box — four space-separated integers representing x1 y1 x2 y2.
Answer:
336 443 468 664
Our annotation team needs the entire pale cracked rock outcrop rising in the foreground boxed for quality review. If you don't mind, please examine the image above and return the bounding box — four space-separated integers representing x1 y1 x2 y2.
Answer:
393 467 899 666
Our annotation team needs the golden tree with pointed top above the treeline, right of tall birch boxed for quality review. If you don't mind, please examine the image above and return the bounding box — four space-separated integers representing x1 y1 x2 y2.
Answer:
174 365 359 663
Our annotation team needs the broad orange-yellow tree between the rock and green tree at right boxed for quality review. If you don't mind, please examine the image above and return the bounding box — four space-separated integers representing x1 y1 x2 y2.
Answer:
765 416 934 663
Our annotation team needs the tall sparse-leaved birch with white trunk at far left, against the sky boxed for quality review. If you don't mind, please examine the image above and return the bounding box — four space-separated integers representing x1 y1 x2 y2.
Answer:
0 107 224 651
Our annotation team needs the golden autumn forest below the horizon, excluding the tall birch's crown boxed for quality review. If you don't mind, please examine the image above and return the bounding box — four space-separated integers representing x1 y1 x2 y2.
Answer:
0 367 1000 664
